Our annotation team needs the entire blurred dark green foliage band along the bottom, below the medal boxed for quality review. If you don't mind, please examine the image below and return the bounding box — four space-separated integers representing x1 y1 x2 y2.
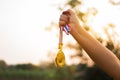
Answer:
0 59 115 80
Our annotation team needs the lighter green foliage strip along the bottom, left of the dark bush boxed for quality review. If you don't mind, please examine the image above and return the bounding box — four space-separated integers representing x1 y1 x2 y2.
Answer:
0 64 71 80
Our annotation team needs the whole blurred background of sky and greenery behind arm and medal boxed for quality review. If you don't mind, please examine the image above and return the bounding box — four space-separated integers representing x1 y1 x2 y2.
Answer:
0 0 120 80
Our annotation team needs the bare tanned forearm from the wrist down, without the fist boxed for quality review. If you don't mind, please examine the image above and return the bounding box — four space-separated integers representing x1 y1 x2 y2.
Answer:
71 25 120 77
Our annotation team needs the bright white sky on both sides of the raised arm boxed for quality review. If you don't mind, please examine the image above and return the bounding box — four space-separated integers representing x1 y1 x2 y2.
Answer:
0 0 120 64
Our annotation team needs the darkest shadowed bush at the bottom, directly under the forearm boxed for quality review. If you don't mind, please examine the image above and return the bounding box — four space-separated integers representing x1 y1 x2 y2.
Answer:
75 64 113 80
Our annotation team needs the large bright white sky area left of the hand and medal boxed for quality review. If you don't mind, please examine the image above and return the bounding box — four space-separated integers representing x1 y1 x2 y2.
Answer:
0 0 63 64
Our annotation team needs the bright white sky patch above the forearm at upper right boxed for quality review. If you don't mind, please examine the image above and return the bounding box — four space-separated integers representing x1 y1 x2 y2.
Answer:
83 0 120 39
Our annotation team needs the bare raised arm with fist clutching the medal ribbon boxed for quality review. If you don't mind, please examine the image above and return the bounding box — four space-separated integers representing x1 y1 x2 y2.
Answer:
59 9 120 80
